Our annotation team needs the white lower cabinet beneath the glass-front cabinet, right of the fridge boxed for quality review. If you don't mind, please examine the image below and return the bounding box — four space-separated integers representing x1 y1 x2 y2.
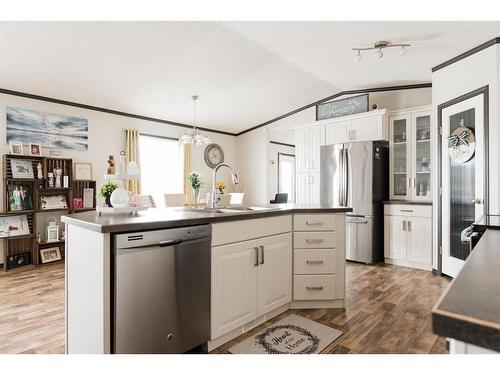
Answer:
384 205 432 271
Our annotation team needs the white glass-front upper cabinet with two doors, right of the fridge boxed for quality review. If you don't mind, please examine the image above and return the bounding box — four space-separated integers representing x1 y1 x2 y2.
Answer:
389 108 432 201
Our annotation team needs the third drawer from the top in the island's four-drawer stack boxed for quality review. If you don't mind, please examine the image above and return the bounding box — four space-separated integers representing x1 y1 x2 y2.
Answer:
293 249 335 275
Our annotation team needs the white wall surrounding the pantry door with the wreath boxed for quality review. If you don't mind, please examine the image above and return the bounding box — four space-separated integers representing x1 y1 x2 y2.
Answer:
432 45 500 268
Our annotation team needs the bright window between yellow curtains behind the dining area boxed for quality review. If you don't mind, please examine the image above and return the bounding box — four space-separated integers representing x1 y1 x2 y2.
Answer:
139 134 184 206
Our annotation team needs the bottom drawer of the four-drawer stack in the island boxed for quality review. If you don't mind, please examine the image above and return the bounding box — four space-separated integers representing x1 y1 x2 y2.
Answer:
293 275 335 300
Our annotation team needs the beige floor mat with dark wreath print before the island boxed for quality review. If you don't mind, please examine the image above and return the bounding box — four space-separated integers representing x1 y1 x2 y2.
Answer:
229 314 342 354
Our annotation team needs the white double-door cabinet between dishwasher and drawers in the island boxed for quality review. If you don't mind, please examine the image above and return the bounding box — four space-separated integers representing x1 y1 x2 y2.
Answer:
211 233 292 340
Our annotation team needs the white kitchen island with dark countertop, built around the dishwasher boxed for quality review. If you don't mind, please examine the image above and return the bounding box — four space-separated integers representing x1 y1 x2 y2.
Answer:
62 204 351 353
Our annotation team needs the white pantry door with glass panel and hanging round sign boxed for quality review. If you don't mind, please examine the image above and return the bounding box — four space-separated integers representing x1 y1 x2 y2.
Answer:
441 95 487 277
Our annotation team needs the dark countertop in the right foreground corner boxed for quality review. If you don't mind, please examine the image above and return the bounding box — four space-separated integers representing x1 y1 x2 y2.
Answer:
432 229 500 351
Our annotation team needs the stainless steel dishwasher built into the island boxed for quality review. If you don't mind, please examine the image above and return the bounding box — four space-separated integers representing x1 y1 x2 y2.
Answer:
113 225 212 353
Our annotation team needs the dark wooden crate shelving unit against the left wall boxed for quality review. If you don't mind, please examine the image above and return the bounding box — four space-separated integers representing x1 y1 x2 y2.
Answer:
0 154 97 271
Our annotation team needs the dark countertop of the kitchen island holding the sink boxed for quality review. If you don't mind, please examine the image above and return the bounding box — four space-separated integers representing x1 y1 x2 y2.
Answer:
61 204 352 233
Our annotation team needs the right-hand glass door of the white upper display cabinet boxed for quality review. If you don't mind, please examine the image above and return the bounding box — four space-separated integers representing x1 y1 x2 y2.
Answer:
410 111 432 201
